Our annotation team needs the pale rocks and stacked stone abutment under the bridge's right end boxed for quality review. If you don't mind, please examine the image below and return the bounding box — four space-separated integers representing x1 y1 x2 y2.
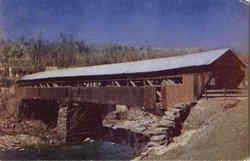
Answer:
104 103 195 159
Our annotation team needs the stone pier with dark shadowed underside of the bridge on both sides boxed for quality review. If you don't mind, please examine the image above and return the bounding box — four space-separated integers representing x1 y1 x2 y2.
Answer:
18 99 115 142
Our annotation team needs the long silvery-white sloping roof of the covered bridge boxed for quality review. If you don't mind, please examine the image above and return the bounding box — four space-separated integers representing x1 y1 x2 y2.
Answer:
21 49 230 81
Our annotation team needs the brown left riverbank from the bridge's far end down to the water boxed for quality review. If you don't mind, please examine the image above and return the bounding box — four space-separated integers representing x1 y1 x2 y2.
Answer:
0 86 61 152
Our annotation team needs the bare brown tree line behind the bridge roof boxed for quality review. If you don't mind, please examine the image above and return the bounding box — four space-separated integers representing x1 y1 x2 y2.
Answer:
0 35 209 75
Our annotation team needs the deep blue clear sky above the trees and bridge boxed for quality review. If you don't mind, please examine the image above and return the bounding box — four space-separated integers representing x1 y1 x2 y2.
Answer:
0 0 249 51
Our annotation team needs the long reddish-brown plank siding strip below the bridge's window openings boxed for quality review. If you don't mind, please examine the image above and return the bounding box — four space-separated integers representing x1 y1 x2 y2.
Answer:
16 87 156 108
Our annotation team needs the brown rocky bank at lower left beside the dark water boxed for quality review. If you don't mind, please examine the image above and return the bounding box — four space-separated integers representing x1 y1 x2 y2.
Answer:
0 118 60 152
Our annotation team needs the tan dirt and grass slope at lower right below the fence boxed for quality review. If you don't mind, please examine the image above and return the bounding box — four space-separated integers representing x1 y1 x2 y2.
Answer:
144 99 248 160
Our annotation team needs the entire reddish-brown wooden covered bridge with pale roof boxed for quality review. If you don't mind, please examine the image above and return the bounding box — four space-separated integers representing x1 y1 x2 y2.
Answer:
16 49 245 142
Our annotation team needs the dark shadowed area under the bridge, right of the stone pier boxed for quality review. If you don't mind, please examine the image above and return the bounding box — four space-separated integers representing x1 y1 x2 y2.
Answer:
66 103 114 142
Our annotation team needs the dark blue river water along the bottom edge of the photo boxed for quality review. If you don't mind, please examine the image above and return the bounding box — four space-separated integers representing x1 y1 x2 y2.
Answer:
0 142 134 160
